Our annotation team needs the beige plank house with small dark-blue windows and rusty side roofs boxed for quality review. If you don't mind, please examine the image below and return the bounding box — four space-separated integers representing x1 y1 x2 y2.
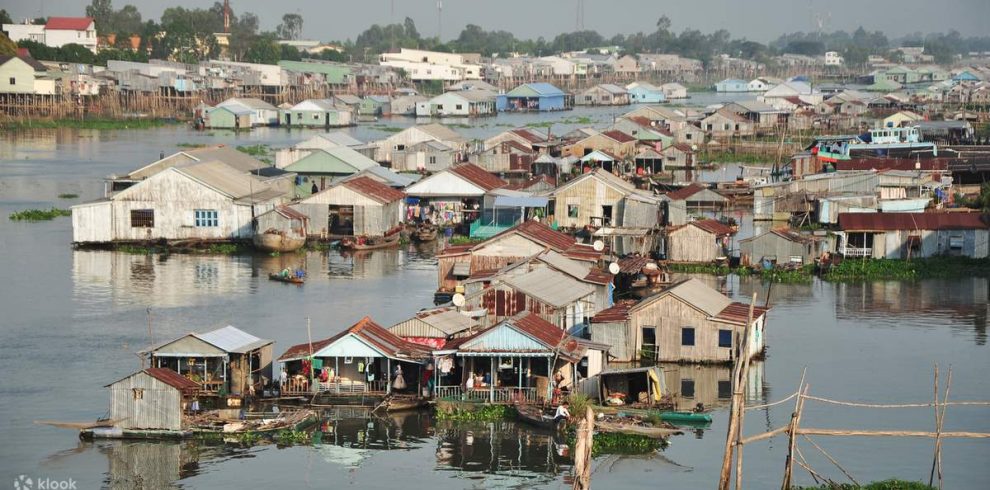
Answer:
590 279 769 363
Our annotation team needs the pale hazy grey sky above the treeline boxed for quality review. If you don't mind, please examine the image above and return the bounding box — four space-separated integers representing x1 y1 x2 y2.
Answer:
0 0 990 42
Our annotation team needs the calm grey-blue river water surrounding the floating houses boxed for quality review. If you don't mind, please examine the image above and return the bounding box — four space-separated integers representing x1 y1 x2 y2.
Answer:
0 105 990 489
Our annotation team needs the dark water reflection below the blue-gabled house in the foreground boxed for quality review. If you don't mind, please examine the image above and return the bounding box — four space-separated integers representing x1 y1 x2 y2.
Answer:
436 421 571 488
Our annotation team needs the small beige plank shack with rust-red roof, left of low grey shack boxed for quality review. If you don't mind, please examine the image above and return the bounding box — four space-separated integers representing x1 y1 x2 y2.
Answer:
664 219 735 264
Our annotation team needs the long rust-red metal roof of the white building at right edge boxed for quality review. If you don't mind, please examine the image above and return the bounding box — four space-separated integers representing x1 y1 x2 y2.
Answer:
839 213 990 231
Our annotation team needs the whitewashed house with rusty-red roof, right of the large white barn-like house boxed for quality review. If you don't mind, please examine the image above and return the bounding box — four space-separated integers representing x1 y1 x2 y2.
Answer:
292 175 406 236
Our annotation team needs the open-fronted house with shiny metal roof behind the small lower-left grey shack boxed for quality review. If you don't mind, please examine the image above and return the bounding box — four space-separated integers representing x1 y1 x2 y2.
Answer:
140 326 275 397
